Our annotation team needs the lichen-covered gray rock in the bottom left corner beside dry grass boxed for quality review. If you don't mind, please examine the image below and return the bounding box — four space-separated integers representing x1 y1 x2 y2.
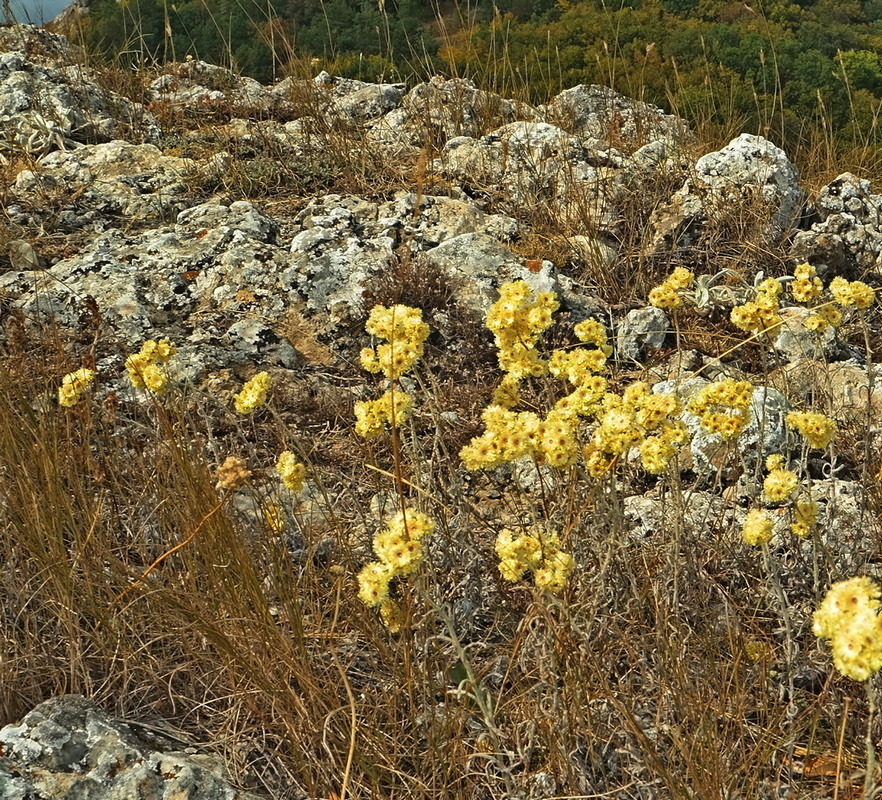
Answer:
0 695 264 800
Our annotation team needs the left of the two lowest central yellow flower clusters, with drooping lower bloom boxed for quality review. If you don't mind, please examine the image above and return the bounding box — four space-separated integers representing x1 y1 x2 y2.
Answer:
358 509 435 633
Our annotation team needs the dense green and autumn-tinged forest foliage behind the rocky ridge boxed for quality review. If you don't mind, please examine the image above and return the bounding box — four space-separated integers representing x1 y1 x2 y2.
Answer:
88 0 882 152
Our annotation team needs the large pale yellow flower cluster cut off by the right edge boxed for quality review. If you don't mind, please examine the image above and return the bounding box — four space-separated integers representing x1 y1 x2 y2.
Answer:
812 577 882 681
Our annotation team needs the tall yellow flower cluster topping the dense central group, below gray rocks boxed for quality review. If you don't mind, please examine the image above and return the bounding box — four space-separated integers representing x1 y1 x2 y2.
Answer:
487 281 558 380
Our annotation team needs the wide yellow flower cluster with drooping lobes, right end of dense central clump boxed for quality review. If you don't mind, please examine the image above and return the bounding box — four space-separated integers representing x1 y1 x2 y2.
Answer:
583 381 689 477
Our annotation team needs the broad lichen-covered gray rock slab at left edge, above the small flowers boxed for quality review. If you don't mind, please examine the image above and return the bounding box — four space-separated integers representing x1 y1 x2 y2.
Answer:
0 201 296 366
